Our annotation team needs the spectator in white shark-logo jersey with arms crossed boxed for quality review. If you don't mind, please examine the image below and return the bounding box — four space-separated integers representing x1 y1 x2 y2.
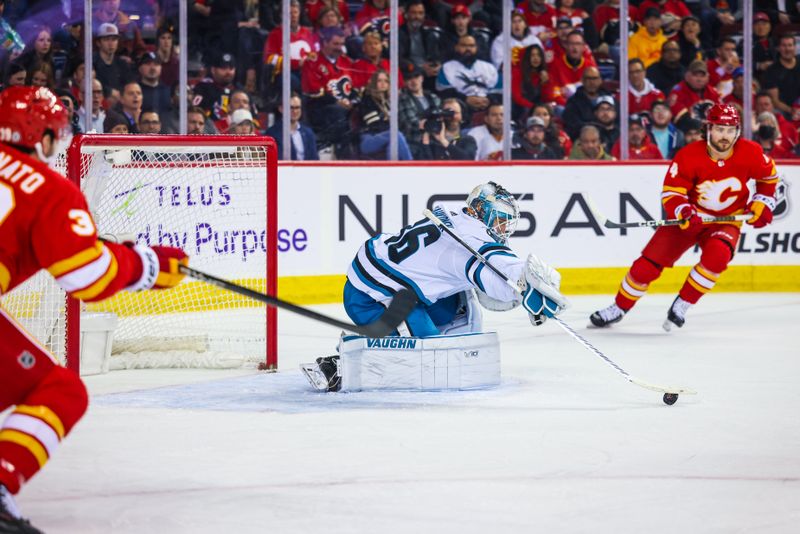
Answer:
436 35 503 111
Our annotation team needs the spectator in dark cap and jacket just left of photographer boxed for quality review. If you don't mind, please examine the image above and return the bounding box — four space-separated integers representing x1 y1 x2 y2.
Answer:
397 61 444 159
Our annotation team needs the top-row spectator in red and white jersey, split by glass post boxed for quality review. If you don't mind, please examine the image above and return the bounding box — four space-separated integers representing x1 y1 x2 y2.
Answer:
264 0 324 92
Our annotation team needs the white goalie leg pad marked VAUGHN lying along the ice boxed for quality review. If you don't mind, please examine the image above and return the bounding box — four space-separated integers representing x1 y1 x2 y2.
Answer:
339 332 500 391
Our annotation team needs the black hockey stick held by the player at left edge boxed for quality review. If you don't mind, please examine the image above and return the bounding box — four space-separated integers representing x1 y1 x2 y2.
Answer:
178 265 417 337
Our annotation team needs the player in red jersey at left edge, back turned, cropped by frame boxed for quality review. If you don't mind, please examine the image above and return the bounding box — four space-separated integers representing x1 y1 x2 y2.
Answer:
0 86 188 532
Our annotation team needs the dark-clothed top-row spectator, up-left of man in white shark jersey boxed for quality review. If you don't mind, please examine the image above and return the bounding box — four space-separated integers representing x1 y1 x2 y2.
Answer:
400 0 442 87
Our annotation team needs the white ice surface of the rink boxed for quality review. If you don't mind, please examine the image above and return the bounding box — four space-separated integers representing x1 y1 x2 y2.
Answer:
12 293 800 534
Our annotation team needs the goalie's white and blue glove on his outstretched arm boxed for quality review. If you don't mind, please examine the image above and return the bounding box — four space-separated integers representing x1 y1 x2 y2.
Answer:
519 254 569 326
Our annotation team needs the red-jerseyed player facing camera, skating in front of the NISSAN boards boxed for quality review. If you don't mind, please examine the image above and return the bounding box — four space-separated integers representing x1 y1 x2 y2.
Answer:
590 104 778 330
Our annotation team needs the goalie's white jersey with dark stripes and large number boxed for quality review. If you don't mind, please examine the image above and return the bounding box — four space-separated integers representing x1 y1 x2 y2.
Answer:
347 204 525 305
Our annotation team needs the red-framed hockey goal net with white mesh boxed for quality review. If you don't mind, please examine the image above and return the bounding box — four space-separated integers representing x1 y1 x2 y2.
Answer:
4 135 277 370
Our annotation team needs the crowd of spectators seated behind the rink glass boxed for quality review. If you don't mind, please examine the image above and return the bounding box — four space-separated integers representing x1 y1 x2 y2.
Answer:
0 0 800 160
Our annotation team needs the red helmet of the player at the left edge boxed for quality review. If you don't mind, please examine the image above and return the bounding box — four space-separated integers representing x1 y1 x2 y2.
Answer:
0 85 72 150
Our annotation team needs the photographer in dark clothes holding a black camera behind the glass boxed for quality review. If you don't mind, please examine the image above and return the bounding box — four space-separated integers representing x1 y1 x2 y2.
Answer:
420 98 478 161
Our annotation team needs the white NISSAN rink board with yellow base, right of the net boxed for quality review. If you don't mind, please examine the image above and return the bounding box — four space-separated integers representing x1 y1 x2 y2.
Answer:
278 162 800 303
